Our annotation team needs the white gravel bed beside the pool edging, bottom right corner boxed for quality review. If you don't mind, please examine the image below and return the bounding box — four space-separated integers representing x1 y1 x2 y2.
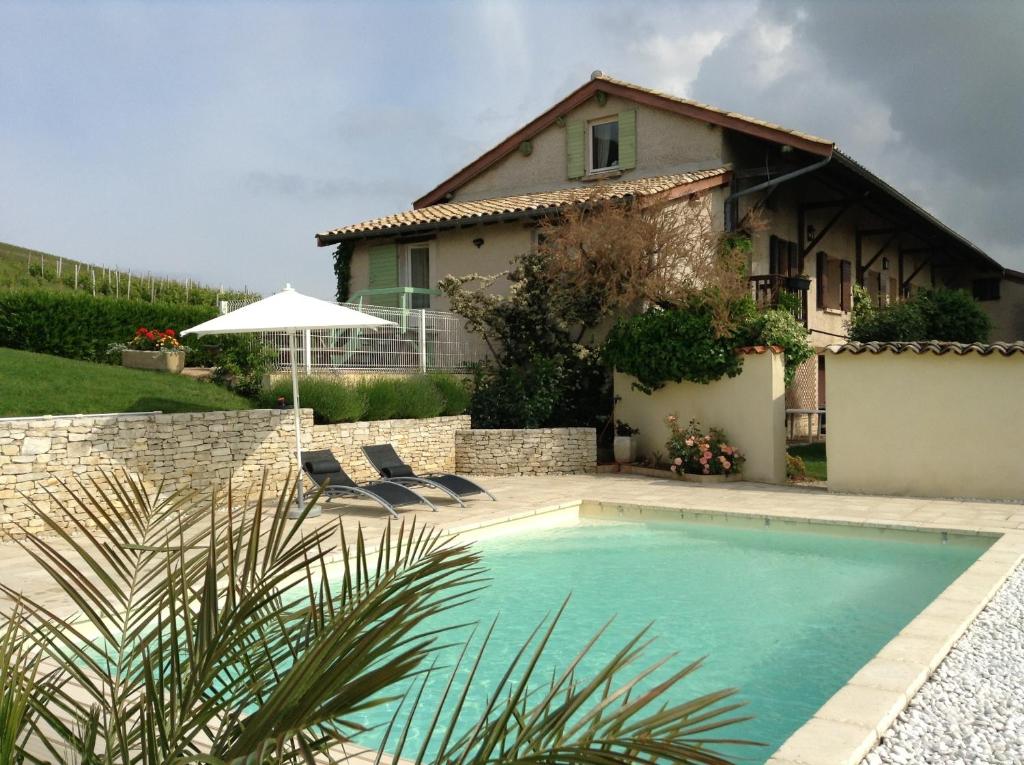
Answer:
862 565 1024 765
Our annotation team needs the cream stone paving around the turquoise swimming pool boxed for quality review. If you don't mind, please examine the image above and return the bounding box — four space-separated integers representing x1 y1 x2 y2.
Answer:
0 474 1024 765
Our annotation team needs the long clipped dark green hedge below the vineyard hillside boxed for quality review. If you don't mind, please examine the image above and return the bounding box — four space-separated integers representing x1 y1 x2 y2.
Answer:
0 290 218 364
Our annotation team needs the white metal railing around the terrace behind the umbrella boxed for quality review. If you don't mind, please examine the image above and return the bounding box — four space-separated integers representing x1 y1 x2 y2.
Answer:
220 300 487 373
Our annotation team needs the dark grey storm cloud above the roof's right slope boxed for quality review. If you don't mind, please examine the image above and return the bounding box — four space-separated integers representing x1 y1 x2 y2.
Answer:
691 0 1024 268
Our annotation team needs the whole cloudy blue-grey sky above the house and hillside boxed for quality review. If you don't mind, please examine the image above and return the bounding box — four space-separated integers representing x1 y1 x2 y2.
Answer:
0 0 1024 297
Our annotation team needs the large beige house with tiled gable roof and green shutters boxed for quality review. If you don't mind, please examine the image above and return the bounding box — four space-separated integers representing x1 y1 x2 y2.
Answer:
316 72 1024 415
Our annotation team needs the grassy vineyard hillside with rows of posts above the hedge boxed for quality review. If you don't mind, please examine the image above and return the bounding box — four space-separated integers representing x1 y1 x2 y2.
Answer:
0 242 251 305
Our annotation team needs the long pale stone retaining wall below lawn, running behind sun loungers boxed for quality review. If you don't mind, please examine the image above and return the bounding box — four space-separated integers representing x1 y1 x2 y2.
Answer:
0 410 470 536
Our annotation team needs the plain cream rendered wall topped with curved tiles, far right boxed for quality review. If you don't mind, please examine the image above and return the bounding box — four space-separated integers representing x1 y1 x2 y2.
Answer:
827 343 1024 500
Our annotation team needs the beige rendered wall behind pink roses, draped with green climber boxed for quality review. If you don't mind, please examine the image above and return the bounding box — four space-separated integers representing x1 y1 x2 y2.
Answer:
614 346 786 483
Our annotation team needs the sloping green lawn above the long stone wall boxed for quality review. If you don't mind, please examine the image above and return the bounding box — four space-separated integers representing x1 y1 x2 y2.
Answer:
0 348 253 417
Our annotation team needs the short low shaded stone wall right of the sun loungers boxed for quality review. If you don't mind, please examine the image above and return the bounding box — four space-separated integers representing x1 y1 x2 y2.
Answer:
455 428 597 475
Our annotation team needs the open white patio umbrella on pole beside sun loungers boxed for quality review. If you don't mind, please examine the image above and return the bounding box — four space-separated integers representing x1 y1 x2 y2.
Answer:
181 285 395 518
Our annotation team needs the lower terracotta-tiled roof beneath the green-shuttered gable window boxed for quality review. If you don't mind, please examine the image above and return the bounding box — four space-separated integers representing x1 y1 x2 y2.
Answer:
316 167 728 245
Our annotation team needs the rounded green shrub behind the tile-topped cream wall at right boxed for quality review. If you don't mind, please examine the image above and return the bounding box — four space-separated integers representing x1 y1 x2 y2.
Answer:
847 287 992 343
